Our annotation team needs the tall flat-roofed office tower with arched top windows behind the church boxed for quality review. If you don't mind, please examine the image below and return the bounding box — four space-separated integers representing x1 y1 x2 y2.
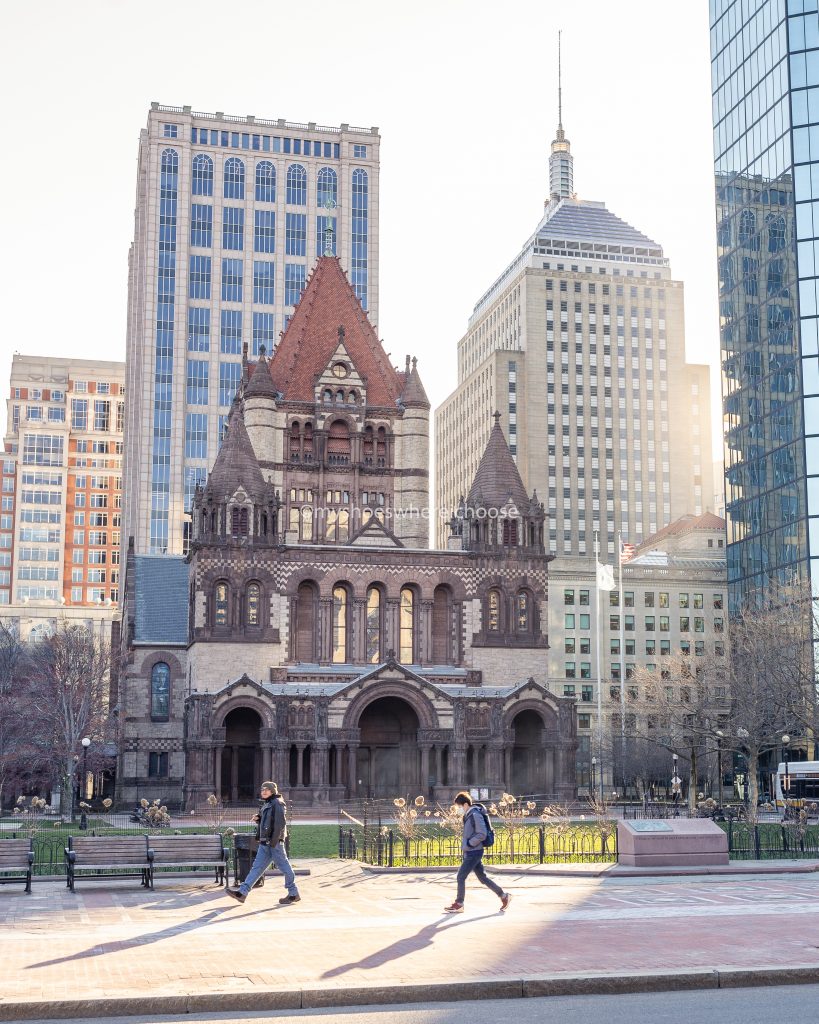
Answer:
125 103 380 554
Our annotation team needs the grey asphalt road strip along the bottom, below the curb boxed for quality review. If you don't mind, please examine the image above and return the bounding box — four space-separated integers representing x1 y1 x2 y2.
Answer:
11 985 819 1024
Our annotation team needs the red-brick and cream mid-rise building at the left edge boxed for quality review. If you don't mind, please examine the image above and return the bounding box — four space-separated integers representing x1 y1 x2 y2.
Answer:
0 355 125 617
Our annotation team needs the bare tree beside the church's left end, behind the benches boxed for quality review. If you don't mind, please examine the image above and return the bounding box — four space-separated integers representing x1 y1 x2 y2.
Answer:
30 624 111 815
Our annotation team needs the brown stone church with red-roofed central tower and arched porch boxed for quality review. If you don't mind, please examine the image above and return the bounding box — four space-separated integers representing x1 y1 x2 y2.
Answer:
116 256 576 807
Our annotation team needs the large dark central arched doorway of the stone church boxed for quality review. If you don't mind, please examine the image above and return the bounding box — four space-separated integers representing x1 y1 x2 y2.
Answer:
356 697 421 797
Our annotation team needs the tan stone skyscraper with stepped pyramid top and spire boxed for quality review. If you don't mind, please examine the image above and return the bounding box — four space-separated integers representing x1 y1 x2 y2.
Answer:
435 111 714 559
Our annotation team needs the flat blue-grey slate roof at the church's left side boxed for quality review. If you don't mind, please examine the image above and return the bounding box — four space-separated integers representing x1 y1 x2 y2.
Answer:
134 555 189 644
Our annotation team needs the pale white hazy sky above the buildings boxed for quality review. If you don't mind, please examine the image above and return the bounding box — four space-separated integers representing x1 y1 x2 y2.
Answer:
0 0 720 456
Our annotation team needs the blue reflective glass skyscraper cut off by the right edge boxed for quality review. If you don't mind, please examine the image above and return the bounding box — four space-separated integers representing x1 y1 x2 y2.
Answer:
710 0 819 610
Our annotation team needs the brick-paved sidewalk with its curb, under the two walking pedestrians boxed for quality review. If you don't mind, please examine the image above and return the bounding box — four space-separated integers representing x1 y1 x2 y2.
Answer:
0 861 819 1020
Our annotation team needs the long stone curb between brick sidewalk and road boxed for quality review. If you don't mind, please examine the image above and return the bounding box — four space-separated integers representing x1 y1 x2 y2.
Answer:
0 964 819 1021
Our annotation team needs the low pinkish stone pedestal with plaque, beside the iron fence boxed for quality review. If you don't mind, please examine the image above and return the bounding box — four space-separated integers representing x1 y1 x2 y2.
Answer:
617 818 728 867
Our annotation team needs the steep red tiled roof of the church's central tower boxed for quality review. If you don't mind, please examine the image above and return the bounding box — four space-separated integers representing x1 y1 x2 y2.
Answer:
266 256 403 408
